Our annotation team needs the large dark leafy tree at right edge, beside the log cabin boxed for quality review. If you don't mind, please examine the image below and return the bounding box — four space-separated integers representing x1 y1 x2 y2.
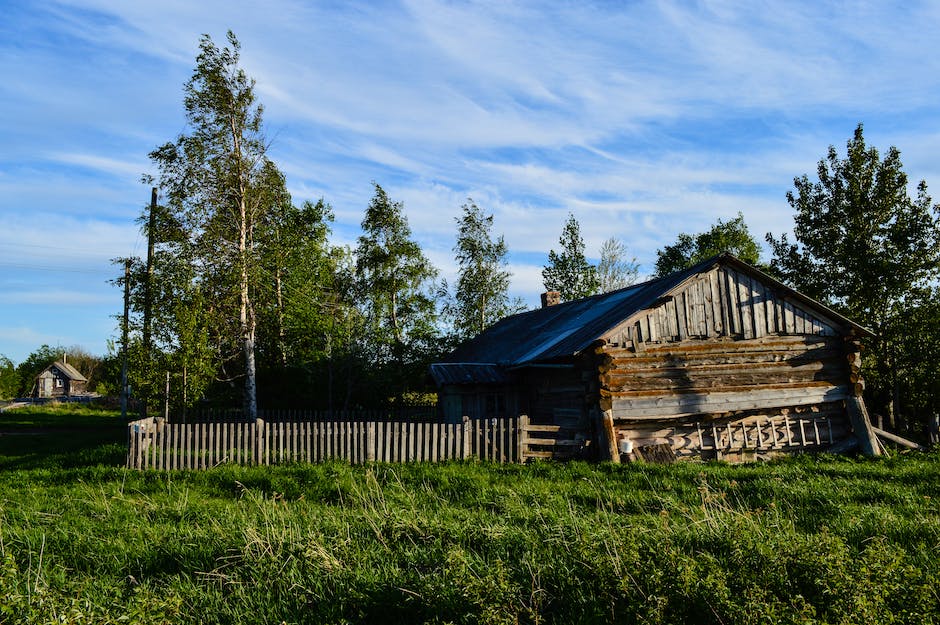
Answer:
767 124 940 432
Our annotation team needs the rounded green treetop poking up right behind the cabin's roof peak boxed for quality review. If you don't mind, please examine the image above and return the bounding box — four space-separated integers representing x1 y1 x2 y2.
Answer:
655 213 760 277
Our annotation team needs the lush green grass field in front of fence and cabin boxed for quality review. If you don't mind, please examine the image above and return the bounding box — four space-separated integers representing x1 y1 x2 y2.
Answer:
0 410 940 624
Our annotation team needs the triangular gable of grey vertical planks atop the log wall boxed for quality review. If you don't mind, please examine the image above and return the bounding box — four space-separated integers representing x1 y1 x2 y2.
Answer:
602 265 838 348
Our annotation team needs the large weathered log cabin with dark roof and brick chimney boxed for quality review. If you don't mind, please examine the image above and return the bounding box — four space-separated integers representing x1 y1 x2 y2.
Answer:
430 254 878 462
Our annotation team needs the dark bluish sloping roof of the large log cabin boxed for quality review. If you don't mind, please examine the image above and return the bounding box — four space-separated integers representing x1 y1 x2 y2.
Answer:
431 253 871 384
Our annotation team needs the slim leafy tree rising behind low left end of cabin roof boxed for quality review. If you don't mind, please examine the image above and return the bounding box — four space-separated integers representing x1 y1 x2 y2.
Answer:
447 199 521 340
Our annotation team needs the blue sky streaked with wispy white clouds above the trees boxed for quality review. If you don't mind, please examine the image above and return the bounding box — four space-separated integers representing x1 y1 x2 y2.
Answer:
0 0 940 362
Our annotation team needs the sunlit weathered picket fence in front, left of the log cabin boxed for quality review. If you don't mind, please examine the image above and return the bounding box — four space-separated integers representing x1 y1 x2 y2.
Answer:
127 415 551 469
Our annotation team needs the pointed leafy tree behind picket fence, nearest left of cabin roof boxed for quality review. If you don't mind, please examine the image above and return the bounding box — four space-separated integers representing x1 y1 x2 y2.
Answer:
356 183 437 397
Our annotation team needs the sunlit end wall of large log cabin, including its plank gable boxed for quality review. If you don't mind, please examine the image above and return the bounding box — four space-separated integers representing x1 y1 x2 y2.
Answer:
595 266 860 457
